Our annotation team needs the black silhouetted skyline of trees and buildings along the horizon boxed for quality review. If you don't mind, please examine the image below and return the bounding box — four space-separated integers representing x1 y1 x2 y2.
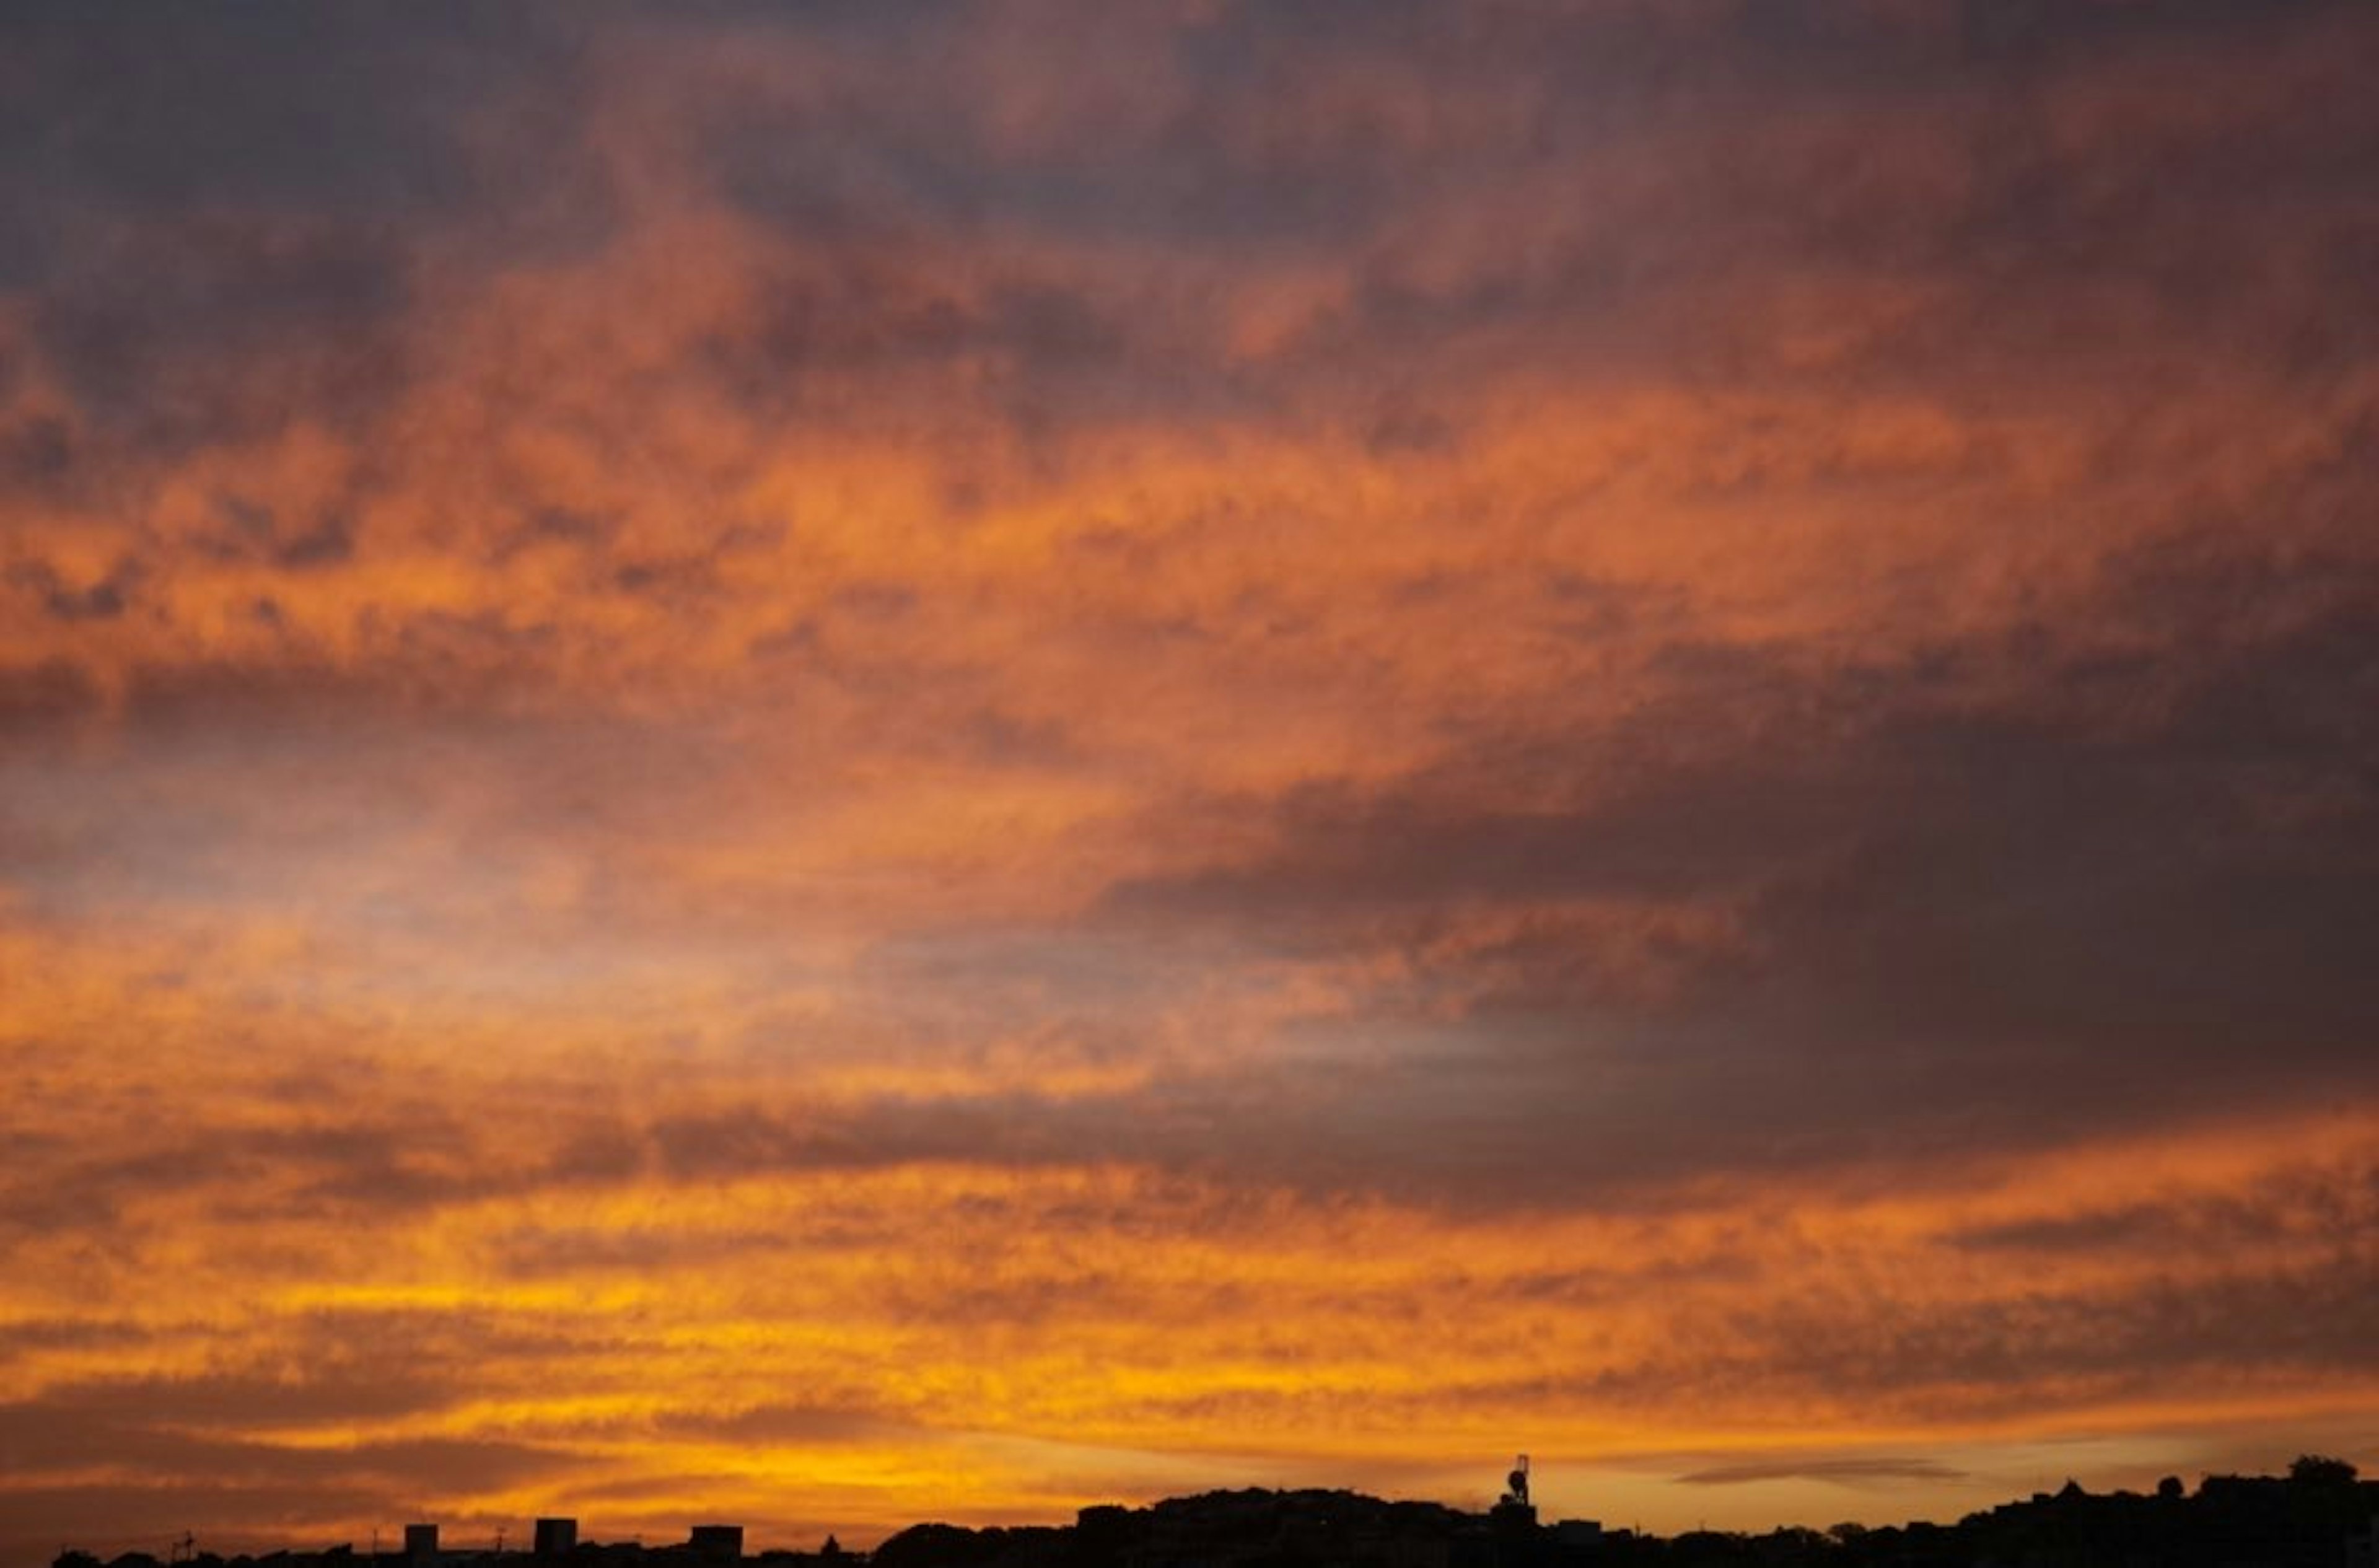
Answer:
52 1454 2379 1568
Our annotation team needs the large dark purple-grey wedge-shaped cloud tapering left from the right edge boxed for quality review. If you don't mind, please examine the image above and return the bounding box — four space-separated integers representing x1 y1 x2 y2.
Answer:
1075 521 2379 1180
